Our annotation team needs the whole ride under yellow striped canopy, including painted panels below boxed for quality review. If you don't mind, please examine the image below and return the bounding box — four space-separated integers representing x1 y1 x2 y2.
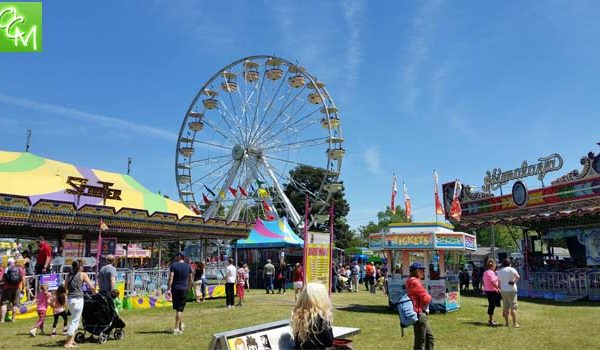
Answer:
0 151 252 318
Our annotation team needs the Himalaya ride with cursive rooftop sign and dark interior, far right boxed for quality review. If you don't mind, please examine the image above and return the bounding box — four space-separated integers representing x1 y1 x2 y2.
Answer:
443 144 600 302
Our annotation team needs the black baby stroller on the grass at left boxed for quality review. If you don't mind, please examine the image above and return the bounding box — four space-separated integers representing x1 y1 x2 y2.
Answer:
75 292 125 344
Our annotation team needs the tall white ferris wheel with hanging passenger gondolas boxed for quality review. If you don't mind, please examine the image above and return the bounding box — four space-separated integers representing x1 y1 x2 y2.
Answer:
175 56 345 227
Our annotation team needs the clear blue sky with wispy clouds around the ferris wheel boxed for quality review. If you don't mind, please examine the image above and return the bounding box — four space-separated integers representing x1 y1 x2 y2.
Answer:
0 0 600 227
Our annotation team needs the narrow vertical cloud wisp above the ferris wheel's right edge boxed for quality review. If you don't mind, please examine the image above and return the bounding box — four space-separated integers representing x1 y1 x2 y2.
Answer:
343 0 365 83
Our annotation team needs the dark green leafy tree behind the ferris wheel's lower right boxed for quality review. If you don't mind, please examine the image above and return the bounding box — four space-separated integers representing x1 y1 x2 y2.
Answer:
280 165 353 248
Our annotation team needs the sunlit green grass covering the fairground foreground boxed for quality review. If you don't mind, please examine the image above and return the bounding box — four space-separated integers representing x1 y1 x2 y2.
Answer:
0 290 600 350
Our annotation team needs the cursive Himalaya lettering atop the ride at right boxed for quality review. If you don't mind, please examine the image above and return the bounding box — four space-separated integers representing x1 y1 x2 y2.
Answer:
482 153 563 192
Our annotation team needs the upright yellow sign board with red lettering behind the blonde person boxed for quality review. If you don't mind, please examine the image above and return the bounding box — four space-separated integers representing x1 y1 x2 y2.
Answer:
304 231 331 290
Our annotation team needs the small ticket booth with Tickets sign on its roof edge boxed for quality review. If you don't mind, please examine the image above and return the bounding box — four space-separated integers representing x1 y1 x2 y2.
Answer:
369 223 477 312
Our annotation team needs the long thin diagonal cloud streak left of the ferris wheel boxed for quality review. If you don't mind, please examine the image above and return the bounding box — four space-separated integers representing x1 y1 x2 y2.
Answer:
0 93 177 141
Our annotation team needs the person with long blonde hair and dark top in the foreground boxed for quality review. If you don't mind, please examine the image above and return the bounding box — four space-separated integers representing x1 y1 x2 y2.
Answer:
290 283 333 349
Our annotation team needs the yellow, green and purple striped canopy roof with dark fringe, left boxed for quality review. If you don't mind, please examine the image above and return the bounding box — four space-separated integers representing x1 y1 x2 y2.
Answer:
0 150 251 241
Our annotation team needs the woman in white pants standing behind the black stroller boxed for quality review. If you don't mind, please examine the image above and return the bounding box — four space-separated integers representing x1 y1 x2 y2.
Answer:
65 261 96 348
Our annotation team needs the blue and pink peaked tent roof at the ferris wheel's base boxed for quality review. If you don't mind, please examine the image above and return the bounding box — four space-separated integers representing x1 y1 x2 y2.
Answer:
237 218 304 249
